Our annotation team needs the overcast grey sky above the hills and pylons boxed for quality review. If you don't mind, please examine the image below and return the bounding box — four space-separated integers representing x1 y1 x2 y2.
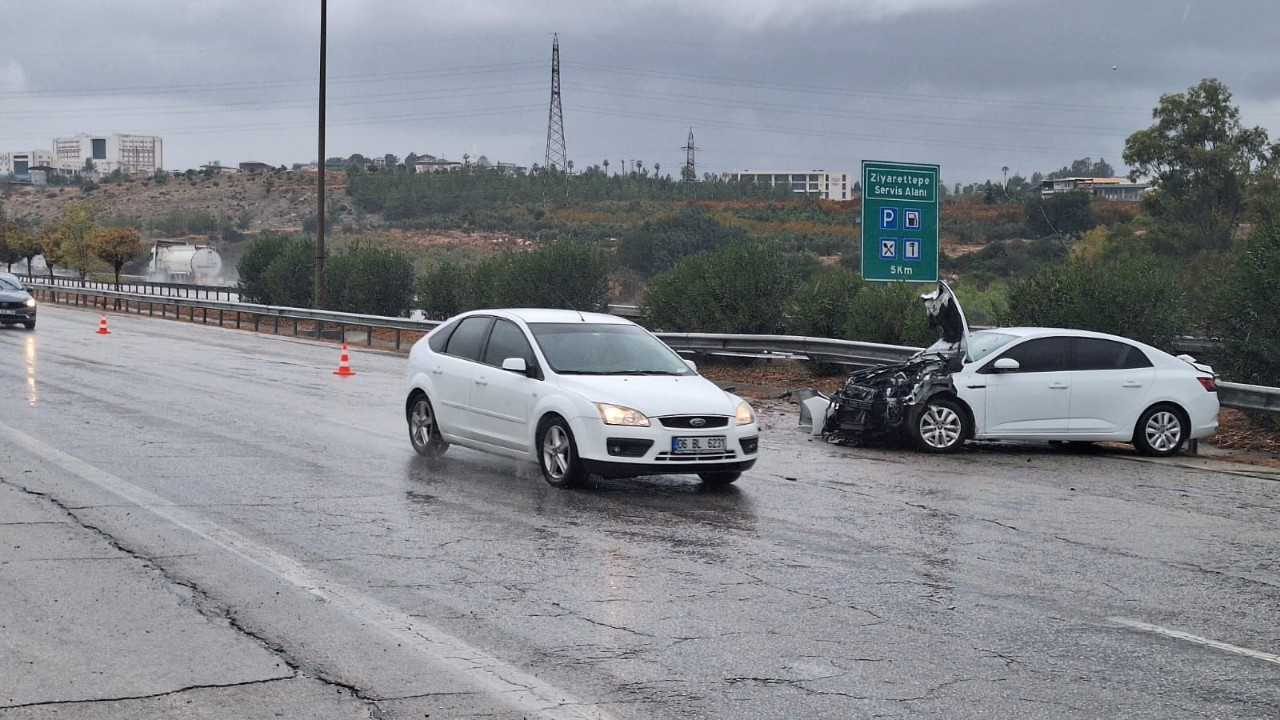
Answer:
0 0 1280 183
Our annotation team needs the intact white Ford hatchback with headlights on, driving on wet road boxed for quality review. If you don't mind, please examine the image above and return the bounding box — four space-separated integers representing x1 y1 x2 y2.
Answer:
404 309 759 487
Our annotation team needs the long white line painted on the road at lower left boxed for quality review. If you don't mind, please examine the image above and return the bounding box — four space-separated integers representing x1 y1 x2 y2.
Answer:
0 423 612 720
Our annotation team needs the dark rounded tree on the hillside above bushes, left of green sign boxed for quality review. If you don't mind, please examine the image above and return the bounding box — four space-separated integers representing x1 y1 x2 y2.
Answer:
618 208 748 277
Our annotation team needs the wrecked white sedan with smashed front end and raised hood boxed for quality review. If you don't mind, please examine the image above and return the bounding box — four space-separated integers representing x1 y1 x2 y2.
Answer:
822 282 1219 456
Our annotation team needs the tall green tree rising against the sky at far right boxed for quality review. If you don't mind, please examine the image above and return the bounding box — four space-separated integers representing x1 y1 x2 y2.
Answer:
1124 78 1275 254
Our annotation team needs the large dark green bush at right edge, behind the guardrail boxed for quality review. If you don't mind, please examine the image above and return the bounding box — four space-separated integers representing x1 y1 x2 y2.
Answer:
1204 222 1280 386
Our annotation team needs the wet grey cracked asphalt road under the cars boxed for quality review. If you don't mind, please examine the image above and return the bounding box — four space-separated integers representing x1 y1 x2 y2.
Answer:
0 305 1280 719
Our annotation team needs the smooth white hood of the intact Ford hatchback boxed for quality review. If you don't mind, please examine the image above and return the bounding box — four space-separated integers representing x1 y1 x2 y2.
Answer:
557 375 740 418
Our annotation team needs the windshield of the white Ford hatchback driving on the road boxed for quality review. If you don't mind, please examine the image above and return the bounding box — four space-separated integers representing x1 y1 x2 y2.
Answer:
529 323 694 375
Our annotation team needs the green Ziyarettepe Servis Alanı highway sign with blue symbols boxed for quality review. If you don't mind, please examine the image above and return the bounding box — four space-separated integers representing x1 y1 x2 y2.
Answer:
863 160 938 283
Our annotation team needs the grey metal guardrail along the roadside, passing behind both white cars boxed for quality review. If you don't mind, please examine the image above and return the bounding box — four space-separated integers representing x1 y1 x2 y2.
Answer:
31 281 1280 413
